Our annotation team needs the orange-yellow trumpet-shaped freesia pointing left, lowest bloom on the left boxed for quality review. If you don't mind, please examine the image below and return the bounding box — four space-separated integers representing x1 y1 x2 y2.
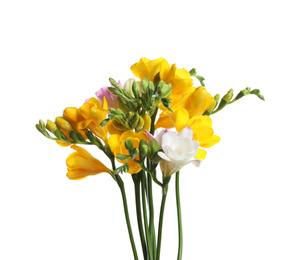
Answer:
66 145 111 180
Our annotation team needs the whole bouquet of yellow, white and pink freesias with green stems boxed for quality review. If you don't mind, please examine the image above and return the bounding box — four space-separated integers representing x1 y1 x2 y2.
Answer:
36 58 264 260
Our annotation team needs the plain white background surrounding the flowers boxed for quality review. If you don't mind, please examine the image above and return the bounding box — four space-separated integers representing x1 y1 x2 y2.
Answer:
0 0 301 260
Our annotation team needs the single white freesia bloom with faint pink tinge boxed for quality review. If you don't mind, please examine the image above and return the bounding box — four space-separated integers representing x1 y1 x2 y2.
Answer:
156 127 201 176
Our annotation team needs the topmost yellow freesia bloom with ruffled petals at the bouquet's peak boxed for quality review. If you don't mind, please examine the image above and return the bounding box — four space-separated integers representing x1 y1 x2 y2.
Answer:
131 58 193 98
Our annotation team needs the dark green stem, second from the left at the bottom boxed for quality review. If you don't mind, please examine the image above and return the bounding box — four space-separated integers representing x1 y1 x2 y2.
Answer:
132 172 148 260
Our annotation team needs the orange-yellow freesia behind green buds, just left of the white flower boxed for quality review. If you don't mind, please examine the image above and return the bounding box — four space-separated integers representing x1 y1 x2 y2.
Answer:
108 130 148 173
